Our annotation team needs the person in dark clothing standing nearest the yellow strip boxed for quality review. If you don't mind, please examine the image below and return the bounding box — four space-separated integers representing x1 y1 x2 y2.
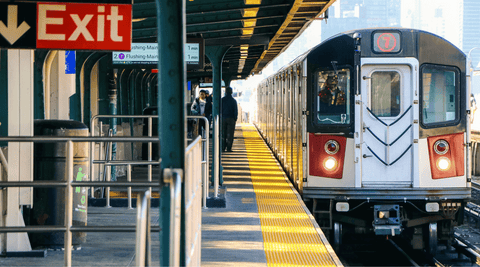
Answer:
222 87 238 152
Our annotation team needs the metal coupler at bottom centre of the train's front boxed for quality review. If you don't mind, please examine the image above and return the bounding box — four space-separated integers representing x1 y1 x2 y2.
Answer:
372 205 402 236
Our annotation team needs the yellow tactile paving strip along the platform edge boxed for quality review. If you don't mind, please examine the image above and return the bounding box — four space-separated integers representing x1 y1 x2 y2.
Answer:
241 124 341 266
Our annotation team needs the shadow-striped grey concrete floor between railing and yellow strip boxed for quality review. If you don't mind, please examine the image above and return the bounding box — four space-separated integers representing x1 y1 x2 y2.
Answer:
202 125 267 266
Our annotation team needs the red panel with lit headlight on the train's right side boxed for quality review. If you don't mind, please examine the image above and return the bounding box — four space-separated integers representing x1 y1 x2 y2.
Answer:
427 133 465 179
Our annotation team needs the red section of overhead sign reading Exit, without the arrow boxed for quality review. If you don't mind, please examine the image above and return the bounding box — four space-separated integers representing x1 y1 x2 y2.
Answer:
37 3 132 51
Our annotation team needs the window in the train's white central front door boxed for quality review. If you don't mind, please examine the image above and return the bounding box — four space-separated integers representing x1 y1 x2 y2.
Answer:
370 71 401 117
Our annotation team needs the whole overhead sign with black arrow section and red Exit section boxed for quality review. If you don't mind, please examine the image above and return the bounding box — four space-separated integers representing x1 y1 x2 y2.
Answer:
0 2 132 51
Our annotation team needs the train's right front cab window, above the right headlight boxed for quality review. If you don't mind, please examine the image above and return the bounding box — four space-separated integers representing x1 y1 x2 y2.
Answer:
421 65 458 124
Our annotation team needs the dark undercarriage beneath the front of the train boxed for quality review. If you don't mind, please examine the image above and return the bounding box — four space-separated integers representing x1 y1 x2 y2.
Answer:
305 199 466 256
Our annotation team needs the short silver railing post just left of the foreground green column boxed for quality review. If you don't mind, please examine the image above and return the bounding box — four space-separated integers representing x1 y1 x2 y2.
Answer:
135 190 151 267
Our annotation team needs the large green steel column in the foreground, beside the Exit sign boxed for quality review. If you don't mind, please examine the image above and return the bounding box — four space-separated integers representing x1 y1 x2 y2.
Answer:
155 0 186 266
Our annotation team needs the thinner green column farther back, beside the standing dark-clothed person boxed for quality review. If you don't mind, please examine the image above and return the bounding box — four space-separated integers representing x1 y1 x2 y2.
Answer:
205 46 230 184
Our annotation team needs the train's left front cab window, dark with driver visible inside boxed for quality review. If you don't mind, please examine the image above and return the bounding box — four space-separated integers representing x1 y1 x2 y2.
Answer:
316 69 351 124
